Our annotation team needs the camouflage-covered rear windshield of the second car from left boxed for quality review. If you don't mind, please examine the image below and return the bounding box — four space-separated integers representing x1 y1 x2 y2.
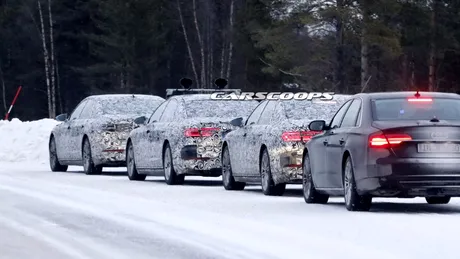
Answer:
185 100 258 118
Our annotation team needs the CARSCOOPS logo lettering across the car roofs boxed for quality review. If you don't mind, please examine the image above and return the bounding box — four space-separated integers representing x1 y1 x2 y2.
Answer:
211 92 334 101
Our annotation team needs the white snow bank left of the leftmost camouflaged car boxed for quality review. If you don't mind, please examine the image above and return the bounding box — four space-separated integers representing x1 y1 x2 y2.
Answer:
0 119 59 164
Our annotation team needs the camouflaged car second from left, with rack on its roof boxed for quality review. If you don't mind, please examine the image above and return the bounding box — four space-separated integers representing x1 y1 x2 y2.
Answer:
127 94 258 184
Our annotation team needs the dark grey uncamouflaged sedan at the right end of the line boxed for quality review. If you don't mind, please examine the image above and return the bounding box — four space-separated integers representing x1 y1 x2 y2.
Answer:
303 92 460 211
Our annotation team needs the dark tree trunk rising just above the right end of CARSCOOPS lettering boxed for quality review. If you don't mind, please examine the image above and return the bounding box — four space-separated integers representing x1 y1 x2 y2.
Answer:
335 0 344 93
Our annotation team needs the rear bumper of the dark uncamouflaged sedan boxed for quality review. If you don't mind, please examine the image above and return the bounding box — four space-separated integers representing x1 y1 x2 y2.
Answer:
356 158 460 197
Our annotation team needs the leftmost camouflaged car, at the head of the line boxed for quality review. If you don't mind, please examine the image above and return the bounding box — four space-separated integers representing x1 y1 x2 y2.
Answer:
49 95 165 174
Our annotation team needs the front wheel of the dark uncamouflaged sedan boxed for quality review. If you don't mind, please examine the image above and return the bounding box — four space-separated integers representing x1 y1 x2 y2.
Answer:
302 153 329 204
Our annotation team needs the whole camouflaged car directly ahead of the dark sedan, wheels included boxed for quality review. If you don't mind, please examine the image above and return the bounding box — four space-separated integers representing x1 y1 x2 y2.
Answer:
222 95 349 195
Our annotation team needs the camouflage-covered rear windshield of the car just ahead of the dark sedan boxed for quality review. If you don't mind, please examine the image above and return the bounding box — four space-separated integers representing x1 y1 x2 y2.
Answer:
282 100 343 120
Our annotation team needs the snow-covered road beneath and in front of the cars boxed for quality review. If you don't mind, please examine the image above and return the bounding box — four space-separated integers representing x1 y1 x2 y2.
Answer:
0 164 460 259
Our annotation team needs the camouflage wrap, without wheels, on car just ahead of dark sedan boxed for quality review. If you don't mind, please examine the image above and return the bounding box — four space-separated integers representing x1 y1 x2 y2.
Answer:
223 96 348 184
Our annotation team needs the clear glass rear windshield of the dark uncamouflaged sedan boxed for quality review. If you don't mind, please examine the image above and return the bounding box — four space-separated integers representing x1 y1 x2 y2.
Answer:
373 98 460 121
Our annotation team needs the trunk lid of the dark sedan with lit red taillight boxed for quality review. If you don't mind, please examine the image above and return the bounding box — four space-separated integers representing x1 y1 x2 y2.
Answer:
371 121 460 158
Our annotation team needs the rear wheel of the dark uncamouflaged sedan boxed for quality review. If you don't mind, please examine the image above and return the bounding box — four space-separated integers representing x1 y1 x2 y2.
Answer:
343 157 372 211
